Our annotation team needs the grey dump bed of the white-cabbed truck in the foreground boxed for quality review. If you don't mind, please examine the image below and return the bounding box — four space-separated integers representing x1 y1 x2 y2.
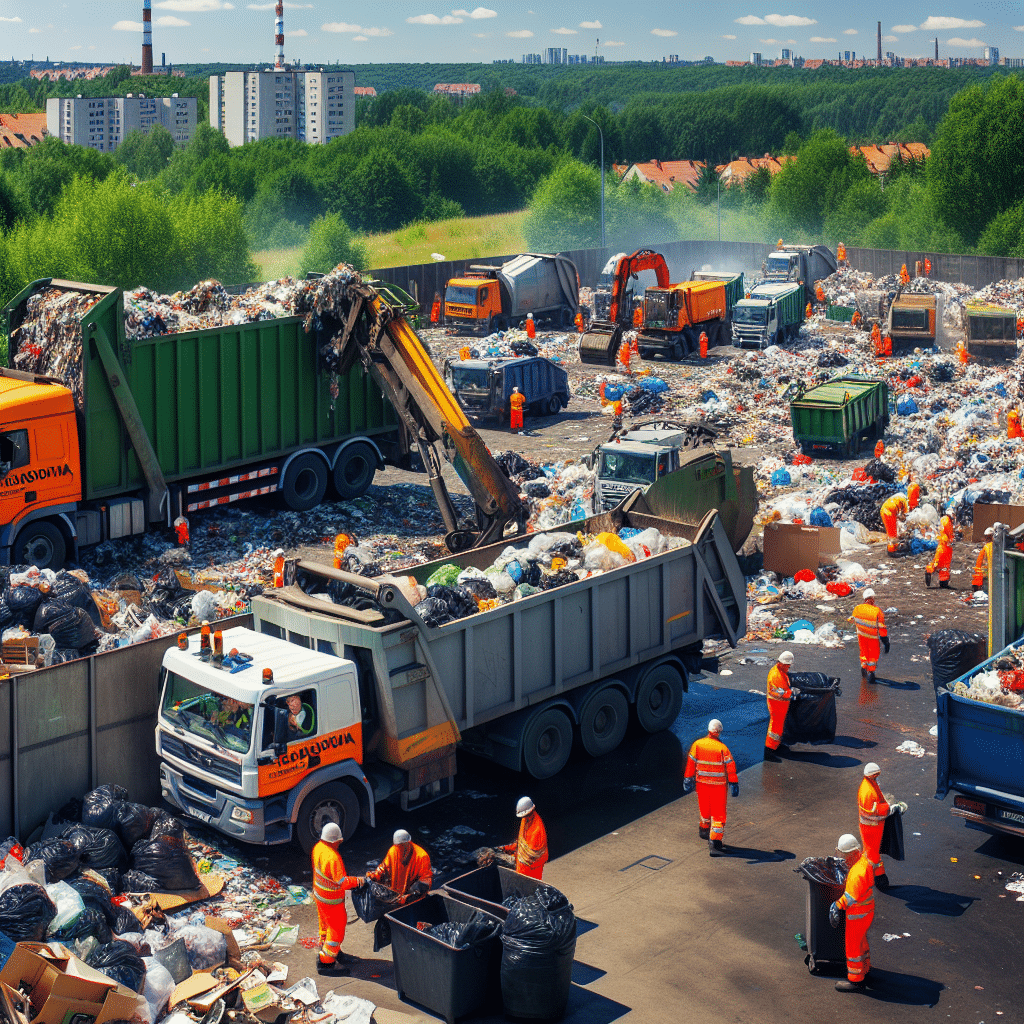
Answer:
252 501 746 777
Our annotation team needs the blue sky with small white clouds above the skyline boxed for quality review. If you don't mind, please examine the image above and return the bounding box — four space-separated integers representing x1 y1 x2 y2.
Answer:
0 0 1024 65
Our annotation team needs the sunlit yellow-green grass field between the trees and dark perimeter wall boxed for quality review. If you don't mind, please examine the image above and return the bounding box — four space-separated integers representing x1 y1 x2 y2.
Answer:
253 210 527 281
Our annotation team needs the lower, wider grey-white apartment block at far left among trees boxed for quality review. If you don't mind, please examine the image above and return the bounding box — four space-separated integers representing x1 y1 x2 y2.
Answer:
46 92 198 153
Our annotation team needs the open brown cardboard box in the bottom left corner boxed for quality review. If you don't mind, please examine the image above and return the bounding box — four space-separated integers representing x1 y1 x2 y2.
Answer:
0 942 141 1024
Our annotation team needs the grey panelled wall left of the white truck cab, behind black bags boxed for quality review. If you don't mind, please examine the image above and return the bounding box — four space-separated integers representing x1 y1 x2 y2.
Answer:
0 615 252 841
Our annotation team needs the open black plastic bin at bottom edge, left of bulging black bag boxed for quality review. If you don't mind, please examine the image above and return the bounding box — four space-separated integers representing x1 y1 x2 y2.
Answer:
386 893 502 1024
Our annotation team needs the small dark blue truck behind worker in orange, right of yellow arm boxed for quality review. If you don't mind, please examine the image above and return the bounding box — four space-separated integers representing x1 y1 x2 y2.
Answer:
444 355 569 420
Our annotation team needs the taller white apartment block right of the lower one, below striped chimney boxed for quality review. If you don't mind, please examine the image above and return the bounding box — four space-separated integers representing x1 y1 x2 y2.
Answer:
210 69 355 145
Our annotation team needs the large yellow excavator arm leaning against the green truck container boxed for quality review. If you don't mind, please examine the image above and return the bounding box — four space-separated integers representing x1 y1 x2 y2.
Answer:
307 271 526 552
